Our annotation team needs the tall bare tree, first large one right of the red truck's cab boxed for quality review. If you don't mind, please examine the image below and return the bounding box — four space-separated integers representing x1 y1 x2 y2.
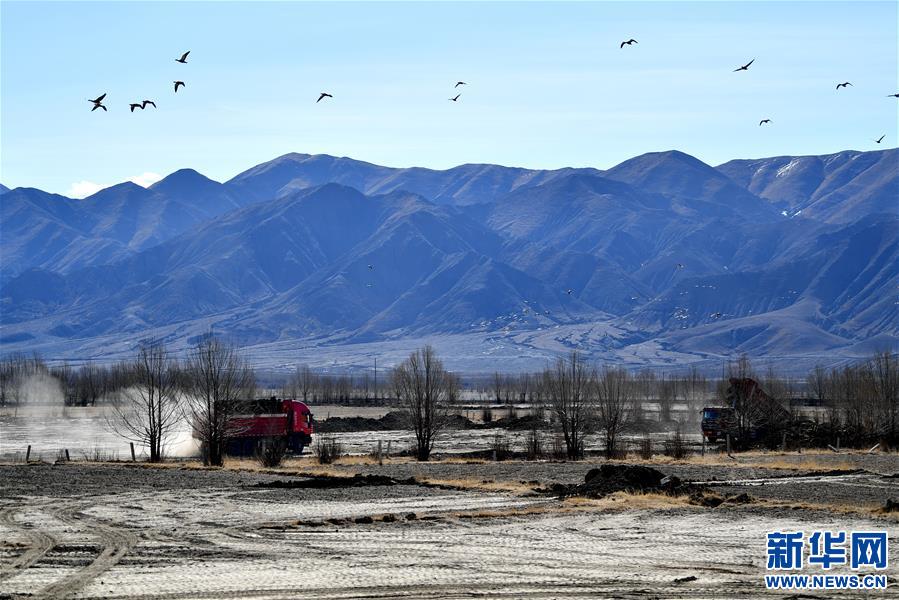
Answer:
392 346 459 460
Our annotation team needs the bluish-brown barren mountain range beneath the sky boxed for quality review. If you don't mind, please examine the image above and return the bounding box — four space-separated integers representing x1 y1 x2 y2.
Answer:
0 149 899 371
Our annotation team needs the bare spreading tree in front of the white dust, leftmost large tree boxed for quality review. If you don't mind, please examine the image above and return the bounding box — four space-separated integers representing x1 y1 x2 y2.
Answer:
110 343 183 462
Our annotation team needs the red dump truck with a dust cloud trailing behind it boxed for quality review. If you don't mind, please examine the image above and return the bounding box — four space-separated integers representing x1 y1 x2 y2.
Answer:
227 396 314 456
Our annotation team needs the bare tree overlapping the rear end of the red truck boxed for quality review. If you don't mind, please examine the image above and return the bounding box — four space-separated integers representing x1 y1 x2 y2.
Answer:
184 336 256 466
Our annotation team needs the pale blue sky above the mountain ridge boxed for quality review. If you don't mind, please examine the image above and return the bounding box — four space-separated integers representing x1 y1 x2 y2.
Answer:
0 0 899 196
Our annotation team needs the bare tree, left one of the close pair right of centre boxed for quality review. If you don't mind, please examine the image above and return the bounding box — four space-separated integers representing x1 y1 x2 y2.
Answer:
542 351 596 460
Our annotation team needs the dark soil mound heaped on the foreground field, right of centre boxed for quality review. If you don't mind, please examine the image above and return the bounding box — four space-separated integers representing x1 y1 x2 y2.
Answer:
543 464 696 498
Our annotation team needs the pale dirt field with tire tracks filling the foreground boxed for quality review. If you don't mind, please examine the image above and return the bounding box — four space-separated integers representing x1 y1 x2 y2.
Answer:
0 455 899 600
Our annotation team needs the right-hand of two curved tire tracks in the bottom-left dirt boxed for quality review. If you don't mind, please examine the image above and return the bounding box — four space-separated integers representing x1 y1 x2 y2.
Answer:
35 507 137 600
